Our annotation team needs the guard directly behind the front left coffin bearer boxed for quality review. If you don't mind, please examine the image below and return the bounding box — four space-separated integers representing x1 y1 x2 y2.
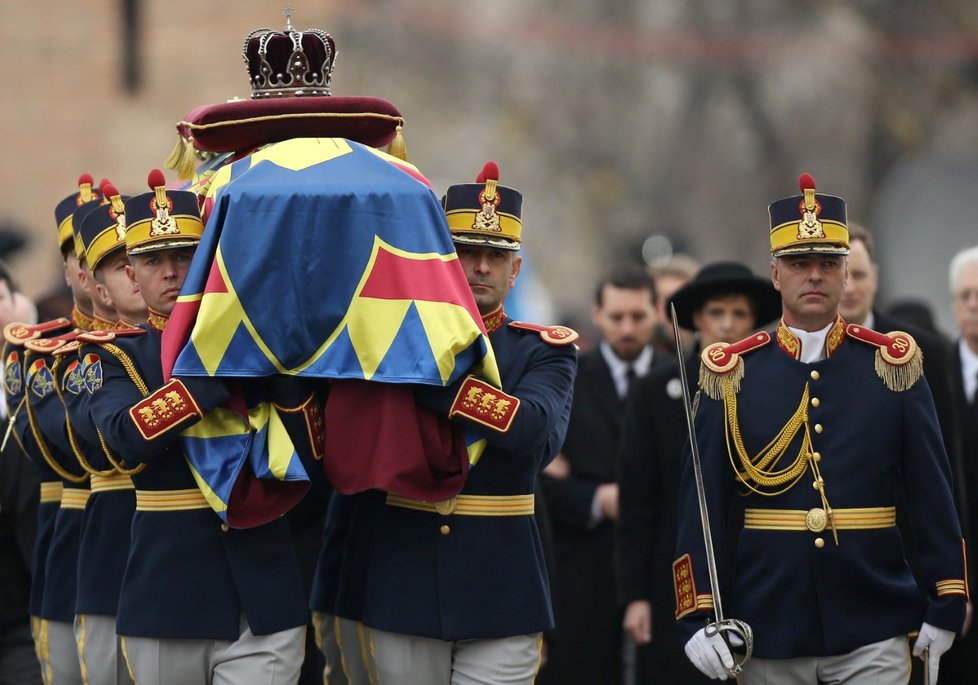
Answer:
67 183 146 685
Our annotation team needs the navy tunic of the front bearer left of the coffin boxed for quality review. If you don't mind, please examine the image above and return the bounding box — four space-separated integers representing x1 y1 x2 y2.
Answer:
83 327 308 640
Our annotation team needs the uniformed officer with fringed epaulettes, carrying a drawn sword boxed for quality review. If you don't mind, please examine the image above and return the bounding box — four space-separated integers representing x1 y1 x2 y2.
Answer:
673 174 967 685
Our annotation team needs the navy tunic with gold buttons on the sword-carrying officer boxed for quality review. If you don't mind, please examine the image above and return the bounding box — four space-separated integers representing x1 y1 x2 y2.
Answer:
677 328 965 659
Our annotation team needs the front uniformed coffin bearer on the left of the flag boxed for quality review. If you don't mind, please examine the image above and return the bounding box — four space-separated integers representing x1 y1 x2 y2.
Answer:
81 170 307 685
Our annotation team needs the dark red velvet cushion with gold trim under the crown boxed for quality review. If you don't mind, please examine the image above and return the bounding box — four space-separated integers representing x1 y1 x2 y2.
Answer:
177 96 404 152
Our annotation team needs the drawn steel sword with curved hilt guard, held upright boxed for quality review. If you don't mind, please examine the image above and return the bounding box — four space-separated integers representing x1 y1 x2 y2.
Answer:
669 303 754 678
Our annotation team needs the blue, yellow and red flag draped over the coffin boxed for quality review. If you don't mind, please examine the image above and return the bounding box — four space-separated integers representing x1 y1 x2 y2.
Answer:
163 139 500 518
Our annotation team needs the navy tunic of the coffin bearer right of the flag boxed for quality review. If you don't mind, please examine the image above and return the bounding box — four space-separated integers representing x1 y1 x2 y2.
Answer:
331 326 577 640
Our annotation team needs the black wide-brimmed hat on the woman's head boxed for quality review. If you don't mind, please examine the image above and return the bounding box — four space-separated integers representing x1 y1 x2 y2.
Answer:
669 262 781 330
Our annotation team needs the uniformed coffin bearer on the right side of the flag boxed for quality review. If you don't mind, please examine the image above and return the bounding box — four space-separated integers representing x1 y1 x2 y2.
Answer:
324 163 577 685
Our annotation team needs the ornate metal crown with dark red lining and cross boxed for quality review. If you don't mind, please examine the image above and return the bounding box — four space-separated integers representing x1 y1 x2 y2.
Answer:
242 6 336 100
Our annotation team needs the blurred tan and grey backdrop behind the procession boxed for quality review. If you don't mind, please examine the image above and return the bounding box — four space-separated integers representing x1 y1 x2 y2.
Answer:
0 0 978 332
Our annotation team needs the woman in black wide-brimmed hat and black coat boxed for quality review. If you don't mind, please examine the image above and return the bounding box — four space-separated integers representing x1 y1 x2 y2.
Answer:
617 262 781 684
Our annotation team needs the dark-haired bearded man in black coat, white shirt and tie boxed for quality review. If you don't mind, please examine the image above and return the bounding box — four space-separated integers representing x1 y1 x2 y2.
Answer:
540 265 664 685
